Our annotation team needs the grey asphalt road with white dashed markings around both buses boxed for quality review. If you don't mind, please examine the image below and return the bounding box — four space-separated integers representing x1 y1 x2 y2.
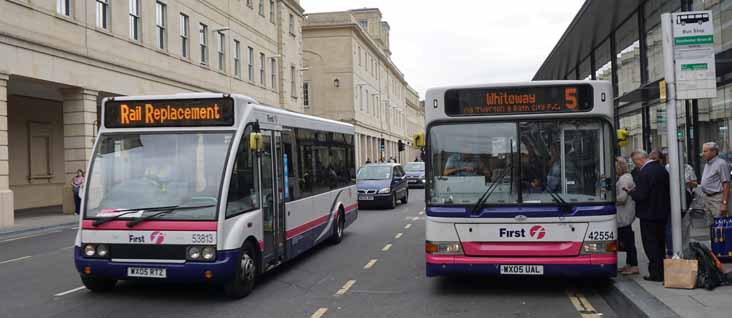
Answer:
0 190 626 318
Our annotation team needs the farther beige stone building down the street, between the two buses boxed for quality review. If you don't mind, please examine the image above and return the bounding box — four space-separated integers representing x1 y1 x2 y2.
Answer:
303 8 419 165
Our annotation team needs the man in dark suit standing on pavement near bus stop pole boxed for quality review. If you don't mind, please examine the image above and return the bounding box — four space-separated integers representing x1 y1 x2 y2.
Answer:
622 150 671 282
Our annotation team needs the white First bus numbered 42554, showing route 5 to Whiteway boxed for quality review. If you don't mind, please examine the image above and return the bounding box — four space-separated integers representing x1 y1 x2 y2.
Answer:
425 81 617 277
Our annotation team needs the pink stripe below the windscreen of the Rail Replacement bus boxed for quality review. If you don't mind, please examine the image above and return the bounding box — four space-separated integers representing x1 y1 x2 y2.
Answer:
82 220 217 231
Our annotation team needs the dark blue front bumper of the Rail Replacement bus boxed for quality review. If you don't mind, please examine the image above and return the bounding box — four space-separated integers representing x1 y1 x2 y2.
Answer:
74 246 241 282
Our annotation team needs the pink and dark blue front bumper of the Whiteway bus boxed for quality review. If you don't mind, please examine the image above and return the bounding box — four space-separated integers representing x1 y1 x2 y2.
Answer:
426 254 618 277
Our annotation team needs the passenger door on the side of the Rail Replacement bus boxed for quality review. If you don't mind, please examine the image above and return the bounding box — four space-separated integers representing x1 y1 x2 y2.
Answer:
261 130 285 268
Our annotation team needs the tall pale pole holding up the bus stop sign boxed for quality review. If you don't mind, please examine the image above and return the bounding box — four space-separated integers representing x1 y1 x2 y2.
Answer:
661 13 682 256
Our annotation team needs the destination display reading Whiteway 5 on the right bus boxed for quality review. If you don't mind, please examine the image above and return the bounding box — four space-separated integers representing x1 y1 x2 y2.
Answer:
445 85 593 116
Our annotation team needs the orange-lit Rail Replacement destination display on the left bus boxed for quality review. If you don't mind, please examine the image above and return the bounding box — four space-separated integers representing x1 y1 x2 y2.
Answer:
104 98 234 128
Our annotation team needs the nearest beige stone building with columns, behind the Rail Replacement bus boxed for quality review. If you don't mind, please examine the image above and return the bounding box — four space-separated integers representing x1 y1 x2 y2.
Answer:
0 0 304 226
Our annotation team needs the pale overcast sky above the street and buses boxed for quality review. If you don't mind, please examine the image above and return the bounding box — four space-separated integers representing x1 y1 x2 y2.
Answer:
300 0 584 98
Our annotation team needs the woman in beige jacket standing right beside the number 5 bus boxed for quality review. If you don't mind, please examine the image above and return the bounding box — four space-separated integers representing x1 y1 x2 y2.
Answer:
615 157 640 275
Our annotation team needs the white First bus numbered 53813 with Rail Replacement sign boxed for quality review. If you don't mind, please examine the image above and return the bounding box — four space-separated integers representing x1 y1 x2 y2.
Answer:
75 93 358 297
